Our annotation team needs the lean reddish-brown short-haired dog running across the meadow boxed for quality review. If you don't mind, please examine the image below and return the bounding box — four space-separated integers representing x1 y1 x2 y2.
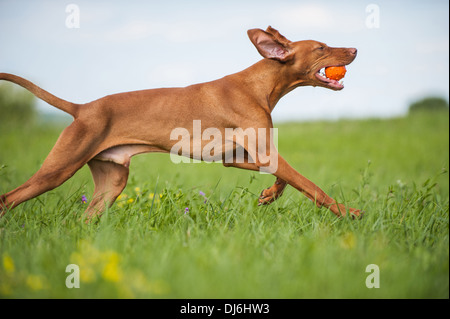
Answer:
0 26 360 219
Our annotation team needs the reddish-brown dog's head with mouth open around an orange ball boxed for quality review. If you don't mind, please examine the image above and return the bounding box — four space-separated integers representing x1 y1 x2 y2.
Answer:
247 26 357 90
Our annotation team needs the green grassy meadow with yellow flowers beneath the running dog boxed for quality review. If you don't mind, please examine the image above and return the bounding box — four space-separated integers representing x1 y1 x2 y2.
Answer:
0 112 449 298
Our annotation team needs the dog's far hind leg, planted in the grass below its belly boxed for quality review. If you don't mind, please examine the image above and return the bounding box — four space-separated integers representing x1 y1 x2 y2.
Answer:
85 159 129 222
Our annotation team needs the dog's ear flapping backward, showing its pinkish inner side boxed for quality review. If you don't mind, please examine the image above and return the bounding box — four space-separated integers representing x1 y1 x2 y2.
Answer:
247 26 292 62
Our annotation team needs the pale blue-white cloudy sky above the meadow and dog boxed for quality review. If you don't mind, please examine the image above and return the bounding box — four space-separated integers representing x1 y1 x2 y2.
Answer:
0 0 449 121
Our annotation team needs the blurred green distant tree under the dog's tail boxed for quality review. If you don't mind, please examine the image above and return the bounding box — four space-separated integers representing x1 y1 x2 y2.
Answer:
0 83 37 126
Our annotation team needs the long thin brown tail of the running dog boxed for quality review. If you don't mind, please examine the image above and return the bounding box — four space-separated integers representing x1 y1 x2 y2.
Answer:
0 73 80 117
